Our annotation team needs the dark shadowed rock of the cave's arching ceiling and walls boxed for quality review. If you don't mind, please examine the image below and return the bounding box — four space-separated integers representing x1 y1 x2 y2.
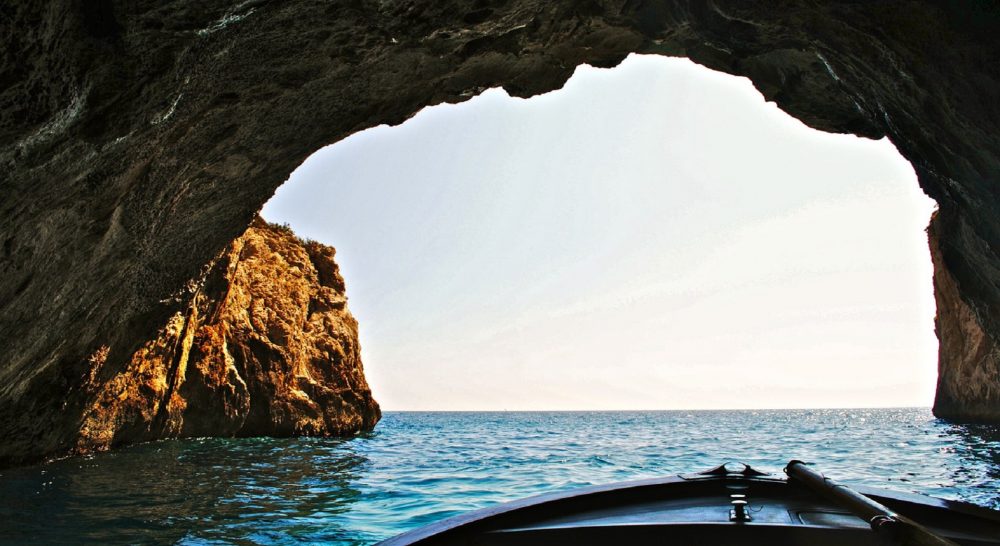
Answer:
0 0 1000 463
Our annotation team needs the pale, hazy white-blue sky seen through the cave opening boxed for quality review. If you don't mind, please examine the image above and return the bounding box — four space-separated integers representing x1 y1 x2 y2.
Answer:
263 56 937 410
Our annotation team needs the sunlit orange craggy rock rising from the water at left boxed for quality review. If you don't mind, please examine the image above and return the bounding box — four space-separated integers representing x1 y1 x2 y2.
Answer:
76 219 381 452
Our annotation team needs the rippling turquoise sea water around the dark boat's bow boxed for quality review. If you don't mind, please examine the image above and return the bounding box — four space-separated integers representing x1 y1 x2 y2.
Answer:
0 408 1000 544
